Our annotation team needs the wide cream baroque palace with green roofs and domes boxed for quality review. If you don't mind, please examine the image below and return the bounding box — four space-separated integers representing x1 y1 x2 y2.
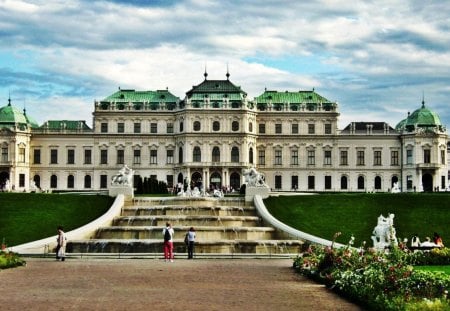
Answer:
0 72 449 192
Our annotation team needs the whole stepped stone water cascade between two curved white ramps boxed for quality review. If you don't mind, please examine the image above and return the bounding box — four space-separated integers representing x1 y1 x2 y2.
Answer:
67 197 303 257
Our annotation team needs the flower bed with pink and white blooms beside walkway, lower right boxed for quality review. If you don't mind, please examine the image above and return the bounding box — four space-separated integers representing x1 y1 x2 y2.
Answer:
294 239 450 310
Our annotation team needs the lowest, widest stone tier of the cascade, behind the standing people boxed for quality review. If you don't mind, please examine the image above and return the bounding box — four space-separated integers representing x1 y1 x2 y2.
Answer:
67 239 302 254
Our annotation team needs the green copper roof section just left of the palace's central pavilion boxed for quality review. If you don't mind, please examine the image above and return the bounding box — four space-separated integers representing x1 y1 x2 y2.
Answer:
102 90 179 103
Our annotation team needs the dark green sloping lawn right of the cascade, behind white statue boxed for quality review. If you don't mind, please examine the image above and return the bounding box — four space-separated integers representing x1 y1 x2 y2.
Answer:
264 193 450 246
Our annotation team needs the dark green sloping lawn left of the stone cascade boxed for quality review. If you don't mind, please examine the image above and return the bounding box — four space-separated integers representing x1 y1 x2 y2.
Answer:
0 193 114 246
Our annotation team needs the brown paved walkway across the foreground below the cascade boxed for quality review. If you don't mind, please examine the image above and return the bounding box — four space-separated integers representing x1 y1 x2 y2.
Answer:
0 258 362 311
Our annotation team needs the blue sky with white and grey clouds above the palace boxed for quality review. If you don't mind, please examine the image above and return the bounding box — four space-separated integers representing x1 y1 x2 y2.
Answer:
0 0 450 128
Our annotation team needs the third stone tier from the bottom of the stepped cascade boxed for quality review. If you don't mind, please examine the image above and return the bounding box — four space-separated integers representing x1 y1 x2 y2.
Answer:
113 215 260 227
